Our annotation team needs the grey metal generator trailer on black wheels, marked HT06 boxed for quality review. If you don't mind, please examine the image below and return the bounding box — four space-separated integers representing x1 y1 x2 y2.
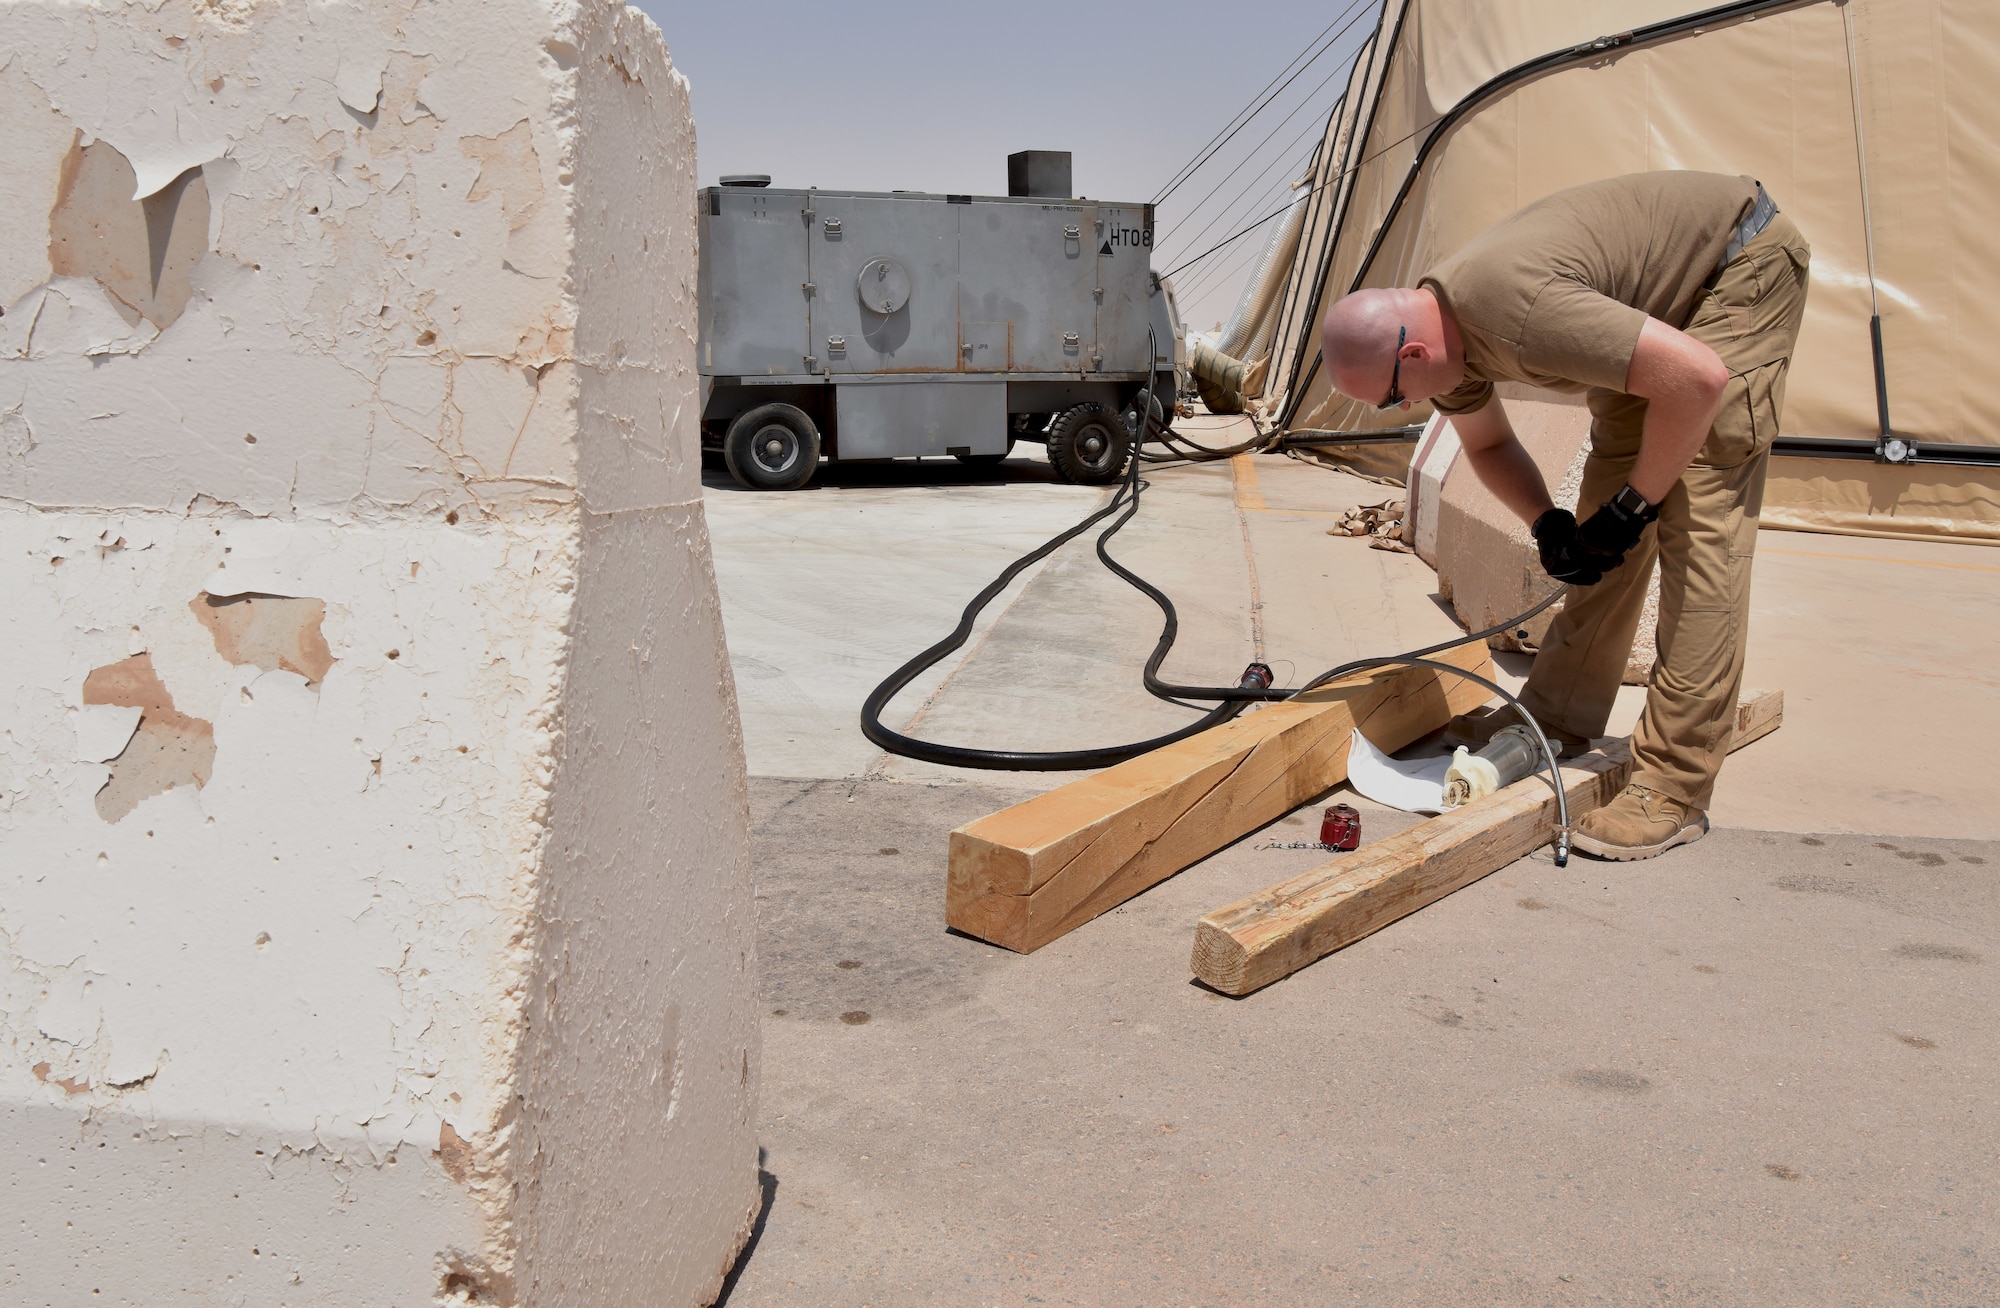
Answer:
696 156 1184 490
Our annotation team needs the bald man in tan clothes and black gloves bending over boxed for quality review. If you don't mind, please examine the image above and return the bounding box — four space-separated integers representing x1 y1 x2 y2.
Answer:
1322 172 1812 858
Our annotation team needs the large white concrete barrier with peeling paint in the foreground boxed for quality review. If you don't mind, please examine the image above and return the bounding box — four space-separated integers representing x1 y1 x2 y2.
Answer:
0 0 758 1306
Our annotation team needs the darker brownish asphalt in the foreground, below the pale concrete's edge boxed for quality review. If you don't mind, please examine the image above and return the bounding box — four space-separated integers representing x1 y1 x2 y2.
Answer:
728 780 2000 1308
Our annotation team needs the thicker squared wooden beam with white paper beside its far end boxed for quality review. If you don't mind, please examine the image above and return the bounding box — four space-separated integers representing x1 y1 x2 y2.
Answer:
944 646 1492 954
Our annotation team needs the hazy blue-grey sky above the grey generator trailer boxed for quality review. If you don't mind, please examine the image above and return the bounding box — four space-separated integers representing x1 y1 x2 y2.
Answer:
640 0 1378 328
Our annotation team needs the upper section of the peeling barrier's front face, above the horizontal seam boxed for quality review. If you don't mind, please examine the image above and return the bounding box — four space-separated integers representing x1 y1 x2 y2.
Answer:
0 4 694 518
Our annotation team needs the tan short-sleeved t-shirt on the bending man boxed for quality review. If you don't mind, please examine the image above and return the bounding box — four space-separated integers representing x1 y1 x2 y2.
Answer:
1418 172 1756 414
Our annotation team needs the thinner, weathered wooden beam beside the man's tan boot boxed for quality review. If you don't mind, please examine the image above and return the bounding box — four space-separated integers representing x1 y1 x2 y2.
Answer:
1190 690 1784 994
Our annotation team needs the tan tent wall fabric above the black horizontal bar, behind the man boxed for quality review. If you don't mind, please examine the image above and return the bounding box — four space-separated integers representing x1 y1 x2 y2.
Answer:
1288 0 2000 462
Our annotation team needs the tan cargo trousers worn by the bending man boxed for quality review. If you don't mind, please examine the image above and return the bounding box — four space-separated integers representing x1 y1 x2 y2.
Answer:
1522 214 1812 810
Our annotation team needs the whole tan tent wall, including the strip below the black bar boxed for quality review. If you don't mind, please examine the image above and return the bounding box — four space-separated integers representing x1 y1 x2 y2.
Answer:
1262 0 2000 542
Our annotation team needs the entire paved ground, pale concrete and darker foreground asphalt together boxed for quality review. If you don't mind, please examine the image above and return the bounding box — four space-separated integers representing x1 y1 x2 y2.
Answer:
710 436 2000 1306
